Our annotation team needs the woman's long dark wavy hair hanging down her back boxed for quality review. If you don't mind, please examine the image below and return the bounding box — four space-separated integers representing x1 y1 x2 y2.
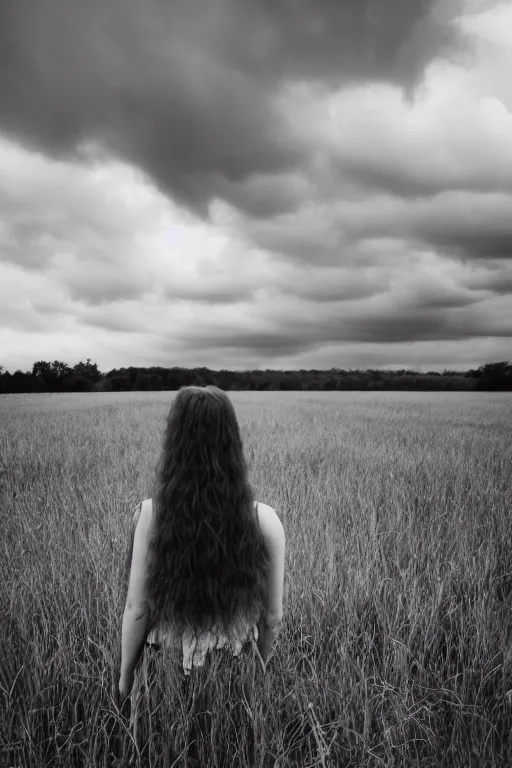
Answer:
140 386 268 635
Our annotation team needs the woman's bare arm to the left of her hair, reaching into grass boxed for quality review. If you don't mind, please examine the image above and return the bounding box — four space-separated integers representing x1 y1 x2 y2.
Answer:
119 507 150 699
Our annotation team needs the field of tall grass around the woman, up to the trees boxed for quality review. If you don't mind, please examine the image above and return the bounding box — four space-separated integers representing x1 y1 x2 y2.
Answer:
0 392 512 768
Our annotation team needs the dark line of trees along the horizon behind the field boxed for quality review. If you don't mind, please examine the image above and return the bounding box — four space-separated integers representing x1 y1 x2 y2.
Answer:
0 358 512 394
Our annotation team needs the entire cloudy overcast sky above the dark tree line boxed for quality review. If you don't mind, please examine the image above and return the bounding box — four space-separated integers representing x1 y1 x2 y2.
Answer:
0 0 512 372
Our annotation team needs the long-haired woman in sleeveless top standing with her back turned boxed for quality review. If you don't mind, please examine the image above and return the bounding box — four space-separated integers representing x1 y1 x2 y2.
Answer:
119 386 285 760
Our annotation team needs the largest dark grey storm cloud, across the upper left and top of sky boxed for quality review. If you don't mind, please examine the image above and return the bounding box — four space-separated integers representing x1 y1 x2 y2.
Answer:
0 0 468 215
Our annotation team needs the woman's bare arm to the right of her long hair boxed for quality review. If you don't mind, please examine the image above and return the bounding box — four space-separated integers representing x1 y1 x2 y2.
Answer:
258 504 285 664
